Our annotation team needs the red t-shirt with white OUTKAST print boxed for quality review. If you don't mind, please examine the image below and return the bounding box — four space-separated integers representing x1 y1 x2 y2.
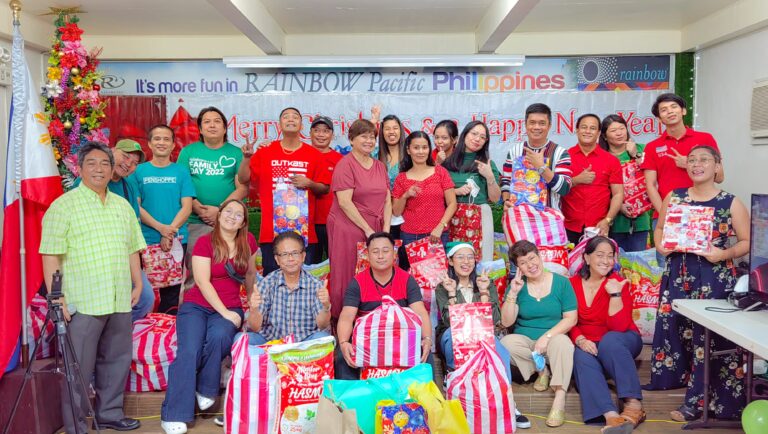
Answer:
250 140 331 244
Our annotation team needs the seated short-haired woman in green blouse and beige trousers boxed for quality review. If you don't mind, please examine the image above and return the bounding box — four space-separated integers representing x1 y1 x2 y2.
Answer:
501 240 578 427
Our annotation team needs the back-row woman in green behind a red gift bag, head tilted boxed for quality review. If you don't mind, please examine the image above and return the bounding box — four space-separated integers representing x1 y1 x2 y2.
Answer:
599 115 653 252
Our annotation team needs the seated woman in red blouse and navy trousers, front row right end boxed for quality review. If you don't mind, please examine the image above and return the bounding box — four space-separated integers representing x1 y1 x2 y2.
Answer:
570 235 645 434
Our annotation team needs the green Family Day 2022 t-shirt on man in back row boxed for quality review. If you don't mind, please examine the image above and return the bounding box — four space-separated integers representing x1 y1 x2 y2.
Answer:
176 142 243 223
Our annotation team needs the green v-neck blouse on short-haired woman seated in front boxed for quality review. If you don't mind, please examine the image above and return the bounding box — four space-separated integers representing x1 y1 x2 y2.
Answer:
512 273 577 340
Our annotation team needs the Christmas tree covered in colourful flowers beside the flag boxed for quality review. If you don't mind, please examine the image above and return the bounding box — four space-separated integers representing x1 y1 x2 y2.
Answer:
43 13 108 189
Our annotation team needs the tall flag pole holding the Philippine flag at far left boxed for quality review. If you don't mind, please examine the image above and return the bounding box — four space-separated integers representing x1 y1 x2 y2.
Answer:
8 0 29 368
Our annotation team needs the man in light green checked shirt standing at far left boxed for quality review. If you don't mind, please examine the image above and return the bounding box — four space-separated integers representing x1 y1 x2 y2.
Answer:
40 142 146 432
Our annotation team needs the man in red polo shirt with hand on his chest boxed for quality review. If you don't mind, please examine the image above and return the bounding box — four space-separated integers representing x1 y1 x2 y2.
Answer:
562 114 624 244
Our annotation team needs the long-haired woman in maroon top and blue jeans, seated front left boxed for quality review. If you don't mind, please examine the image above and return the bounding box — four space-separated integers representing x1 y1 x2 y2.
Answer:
160 199 257 434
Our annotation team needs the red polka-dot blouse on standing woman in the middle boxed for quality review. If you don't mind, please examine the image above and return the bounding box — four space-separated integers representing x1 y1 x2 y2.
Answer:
392 166 454 234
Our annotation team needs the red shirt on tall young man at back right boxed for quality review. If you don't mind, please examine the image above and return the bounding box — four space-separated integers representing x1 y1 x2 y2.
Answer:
640 128 719 200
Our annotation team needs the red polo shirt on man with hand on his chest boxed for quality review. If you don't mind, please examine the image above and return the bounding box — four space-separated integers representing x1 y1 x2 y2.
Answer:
561 145 624 232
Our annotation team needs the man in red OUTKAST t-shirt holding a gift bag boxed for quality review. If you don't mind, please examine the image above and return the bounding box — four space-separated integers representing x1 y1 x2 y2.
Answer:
238 107 331 276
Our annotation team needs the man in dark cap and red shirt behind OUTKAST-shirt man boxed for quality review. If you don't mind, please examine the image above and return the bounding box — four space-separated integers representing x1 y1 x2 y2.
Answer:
309 116 343 263
